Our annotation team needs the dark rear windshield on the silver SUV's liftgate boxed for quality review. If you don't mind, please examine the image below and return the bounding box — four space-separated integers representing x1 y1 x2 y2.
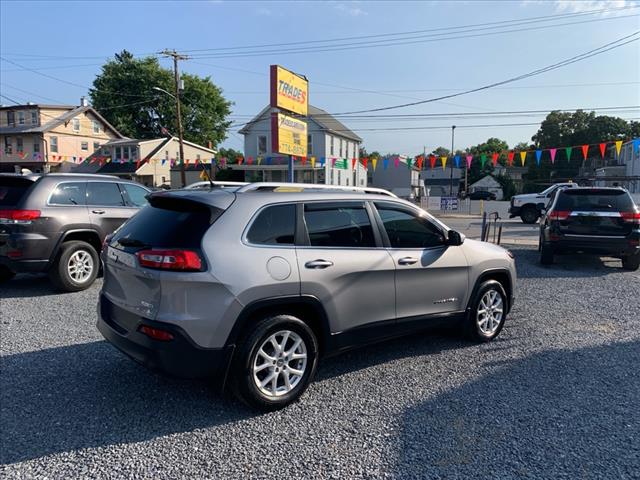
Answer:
112 202 222 249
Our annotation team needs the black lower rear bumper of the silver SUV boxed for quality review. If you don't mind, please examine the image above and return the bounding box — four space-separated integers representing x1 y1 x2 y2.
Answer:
97 294 234 385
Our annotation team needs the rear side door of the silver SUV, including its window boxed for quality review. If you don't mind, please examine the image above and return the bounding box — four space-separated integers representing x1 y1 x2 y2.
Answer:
296 201 395 332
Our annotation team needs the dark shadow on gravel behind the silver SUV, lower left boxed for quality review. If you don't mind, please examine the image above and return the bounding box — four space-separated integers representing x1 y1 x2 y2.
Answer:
0 342 254 464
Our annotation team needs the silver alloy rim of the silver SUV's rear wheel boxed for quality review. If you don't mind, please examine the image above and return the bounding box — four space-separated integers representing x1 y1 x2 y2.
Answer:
253 330 307 397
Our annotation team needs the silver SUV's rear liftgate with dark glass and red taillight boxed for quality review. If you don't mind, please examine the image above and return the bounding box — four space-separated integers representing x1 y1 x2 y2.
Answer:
102 194 224 329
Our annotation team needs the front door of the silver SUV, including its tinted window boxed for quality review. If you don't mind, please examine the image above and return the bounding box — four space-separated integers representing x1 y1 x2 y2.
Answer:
375 202 468 319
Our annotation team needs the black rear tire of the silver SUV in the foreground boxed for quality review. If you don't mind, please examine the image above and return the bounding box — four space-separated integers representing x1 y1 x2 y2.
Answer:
229 315 318 411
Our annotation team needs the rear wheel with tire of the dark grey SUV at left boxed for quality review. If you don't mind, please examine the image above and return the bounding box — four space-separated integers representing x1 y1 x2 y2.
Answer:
49 240 100 292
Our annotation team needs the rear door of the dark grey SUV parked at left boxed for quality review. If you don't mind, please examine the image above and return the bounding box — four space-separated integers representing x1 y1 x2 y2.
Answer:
87 181 137 238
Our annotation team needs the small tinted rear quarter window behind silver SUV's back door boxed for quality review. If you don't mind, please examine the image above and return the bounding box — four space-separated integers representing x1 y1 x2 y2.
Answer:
247 205 296 245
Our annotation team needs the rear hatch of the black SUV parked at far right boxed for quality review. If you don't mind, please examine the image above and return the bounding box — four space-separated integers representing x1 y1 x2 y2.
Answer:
552 188 637 237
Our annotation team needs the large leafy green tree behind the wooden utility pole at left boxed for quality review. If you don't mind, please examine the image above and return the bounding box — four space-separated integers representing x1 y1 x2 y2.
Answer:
89 50 231 146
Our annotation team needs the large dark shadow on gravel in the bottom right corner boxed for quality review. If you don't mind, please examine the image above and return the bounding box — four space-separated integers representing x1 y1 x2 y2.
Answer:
390 341 640 479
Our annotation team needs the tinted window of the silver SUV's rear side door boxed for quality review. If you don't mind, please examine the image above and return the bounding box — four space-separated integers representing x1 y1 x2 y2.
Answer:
304 203 375 248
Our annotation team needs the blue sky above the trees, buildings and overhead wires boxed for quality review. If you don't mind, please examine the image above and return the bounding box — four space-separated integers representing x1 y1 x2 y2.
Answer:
0 0 640 155
